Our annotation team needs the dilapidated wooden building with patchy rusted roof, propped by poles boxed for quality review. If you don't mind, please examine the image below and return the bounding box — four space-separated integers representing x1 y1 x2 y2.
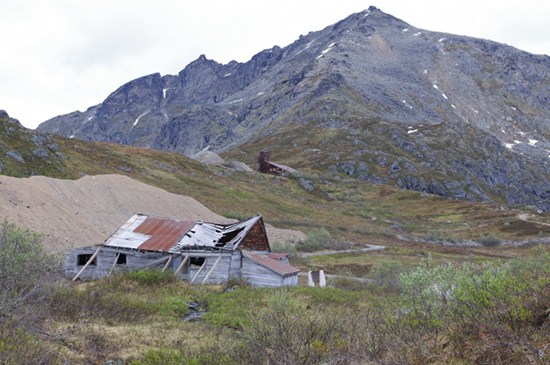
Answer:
65 214 299 287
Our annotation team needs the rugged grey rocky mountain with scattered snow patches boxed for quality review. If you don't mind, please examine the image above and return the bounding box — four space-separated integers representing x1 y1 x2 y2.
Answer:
38 7 550 210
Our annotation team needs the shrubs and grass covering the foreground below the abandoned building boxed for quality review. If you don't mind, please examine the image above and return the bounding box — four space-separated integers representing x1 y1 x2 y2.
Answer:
0 223 550 365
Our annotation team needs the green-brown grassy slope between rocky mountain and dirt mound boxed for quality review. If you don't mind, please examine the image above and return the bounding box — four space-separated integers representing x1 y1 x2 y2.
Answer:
0 112 550 246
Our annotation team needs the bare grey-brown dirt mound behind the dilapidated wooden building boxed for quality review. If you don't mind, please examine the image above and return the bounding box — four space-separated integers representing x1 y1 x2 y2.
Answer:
0 175 304 251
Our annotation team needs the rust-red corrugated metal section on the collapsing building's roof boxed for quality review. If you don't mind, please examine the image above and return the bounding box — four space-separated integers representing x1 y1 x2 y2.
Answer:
134 217 196 252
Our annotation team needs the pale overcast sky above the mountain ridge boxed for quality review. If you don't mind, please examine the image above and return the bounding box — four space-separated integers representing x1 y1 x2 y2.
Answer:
0 0 550 128
